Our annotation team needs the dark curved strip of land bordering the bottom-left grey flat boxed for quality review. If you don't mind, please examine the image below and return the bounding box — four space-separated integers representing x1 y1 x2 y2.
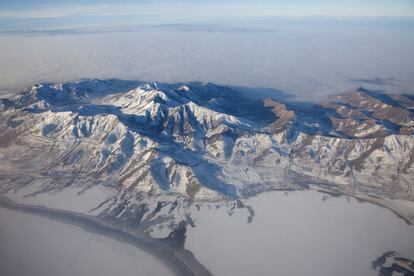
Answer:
0 196 212 276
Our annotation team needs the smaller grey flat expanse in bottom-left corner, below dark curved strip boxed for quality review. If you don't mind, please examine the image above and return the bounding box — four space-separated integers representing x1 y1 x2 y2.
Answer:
0 208 174 276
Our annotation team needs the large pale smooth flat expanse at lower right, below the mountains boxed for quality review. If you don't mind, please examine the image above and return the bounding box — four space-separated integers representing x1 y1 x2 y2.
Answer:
186 192 414 276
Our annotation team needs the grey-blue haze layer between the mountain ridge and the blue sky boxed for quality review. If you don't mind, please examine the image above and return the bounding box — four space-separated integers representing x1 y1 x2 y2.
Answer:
0 17 414 100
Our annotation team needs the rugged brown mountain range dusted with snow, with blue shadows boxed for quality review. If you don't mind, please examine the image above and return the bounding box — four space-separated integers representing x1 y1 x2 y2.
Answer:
0 80 414 230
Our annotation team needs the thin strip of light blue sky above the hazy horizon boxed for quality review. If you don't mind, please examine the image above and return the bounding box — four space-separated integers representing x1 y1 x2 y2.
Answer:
0 0 414 29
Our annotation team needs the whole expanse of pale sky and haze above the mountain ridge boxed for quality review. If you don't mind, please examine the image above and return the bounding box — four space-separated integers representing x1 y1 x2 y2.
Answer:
0 0 414 100
